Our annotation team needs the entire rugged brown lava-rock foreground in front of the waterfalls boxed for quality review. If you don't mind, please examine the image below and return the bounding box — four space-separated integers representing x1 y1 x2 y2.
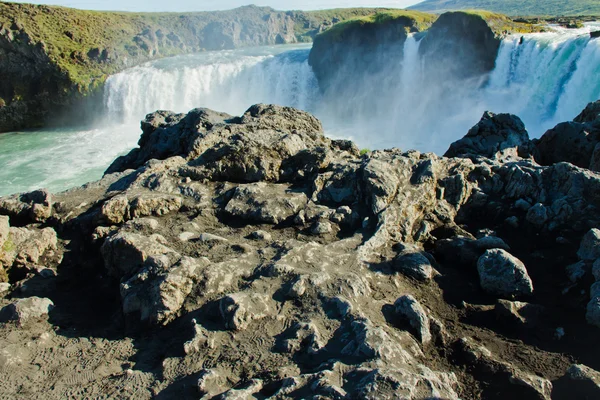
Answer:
0 103 600 399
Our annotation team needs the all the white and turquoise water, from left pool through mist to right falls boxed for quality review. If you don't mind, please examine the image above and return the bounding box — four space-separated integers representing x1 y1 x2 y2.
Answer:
0 24 600 195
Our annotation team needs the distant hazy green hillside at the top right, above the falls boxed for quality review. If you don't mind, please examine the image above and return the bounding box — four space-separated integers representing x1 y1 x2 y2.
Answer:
409 0 600 16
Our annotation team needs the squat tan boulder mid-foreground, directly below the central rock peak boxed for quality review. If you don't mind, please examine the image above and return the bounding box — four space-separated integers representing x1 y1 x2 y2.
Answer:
225 182 308 224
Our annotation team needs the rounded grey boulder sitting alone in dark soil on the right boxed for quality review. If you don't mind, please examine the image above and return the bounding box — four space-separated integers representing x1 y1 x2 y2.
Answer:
477 249 533 298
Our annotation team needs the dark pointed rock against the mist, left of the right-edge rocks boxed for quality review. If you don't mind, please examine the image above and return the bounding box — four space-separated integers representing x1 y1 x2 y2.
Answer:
444 111 534 159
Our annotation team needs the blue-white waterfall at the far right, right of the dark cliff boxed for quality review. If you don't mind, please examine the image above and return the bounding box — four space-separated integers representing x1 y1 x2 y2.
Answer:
482 24 600 131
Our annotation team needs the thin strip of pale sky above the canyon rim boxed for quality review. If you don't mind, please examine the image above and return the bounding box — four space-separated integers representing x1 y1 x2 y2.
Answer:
2 0 420 12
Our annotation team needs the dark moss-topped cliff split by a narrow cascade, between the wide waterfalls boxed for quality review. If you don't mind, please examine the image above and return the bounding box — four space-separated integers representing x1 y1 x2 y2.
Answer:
309 12 520 96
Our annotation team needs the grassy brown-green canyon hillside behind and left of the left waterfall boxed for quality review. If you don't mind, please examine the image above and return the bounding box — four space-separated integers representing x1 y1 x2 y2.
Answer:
0 1 394 132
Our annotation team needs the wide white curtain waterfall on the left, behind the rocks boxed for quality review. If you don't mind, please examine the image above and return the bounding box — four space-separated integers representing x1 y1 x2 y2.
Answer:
105 46 318 123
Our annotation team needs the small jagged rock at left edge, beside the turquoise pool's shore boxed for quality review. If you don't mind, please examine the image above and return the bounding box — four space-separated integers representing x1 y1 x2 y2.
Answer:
0 189 53 222
